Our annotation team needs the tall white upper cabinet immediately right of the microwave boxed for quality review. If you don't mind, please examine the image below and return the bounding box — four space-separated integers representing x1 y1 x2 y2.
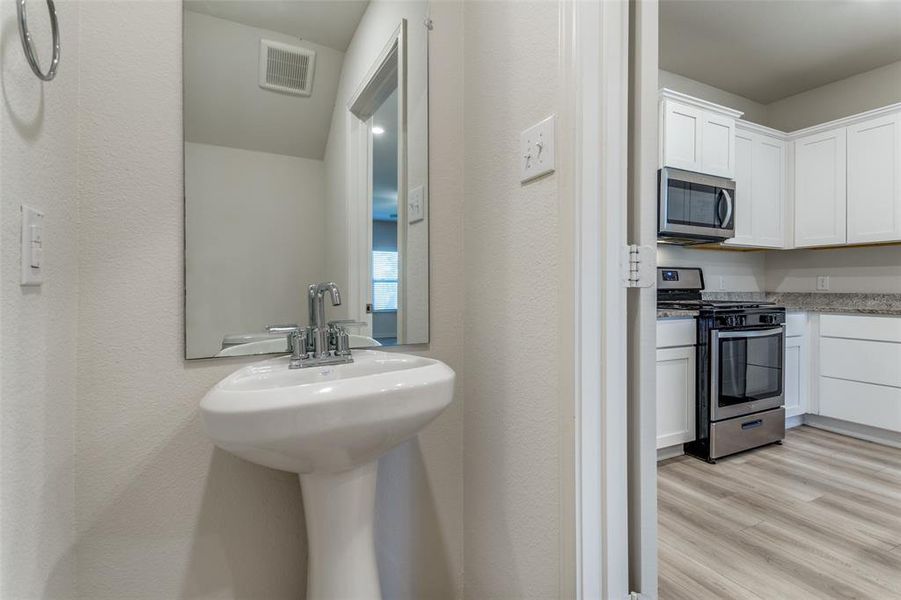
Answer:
725 123 787 248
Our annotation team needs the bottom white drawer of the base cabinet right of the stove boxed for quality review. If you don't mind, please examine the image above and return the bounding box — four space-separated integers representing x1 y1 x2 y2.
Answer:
820 377 901 431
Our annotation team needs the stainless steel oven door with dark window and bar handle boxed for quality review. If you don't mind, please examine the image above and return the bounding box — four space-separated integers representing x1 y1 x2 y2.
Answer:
710 325 785 421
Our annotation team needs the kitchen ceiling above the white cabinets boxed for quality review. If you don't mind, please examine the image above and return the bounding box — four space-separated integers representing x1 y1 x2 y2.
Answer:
660 0 901 104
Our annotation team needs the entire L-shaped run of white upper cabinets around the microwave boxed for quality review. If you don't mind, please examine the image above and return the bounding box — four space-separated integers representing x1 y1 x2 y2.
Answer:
659 89 901 249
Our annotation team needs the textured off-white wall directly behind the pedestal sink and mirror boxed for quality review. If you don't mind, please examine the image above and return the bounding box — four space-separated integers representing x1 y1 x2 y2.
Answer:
74 1 463 600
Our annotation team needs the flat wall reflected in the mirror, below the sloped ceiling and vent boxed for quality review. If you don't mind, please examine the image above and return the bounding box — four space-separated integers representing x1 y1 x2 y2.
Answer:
185 143 325 358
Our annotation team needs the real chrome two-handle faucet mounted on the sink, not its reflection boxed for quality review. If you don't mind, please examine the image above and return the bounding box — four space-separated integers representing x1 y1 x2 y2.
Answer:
288 282 353 369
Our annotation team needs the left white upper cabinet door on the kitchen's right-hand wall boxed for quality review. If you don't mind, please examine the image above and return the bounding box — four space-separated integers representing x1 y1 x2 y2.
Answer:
795 128 847 247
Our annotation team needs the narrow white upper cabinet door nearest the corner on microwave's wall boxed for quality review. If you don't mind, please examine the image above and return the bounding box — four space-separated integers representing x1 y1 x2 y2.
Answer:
751 136 785 248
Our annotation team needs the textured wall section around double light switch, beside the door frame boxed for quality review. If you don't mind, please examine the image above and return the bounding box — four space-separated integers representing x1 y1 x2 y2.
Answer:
460 2 572 599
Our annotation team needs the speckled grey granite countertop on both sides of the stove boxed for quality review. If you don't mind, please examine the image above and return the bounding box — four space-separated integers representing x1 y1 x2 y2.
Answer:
657 292 901 319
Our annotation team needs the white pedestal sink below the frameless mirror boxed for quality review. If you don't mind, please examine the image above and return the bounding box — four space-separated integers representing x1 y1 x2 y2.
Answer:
200 350 454 600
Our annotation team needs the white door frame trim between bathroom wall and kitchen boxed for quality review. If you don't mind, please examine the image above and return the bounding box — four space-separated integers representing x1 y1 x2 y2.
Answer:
561 0 630 600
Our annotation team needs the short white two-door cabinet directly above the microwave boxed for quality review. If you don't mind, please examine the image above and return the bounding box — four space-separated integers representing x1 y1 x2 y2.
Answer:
660 90 741 179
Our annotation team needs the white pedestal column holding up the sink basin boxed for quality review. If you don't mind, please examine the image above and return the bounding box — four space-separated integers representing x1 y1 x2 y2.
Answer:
300 461 382 600
